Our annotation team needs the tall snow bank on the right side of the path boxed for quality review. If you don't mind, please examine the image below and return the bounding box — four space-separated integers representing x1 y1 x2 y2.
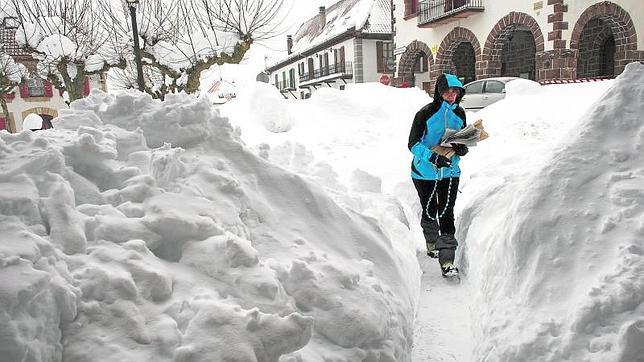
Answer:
459 63 644 361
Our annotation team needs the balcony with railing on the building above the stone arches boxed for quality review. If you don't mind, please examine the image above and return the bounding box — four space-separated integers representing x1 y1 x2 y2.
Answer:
418 0 485 28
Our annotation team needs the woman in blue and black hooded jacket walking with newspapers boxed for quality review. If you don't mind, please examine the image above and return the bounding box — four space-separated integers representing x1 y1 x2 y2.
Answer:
408 74 468 277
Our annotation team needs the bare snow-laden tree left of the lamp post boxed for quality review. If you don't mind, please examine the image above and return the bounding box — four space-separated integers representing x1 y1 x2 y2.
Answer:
8 0 127 101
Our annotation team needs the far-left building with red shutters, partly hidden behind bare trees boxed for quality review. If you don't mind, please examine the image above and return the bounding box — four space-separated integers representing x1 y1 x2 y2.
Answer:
0 17 106 132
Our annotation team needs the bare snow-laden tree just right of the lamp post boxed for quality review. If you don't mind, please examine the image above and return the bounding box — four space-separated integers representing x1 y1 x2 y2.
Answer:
105 0 284 99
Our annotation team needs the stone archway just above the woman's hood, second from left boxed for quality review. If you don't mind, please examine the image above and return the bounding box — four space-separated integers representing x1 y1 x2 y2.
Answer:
432 27 481 83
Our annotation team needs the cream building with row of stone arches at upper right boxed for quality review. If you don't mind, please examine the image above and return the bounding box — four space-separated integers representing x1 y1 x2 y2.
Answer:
394 0 644 89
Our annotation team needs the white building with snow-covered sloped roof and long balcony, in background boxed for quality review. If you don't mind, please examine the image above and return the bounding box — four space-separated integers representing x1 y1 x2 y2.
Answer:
266 0 394 99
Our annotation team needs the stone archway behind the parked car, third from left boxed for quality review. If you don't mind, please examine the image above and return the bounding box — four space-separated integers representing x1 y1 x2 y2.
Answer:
484 11 544 79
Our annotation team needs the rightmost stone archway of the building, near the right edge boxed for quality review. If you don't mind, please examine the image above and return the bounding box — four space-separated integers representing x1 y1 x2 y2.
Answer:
570 1 641 78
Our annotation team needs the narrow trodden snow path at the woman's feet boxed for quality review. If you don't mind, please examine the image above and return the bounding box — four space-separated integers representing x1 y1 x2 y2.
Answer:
412 255 473 362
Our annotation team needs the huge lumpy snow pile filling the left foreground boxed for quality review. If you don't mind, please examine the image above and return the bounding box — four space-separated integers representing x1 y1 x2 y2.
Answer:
0 92 418 362
